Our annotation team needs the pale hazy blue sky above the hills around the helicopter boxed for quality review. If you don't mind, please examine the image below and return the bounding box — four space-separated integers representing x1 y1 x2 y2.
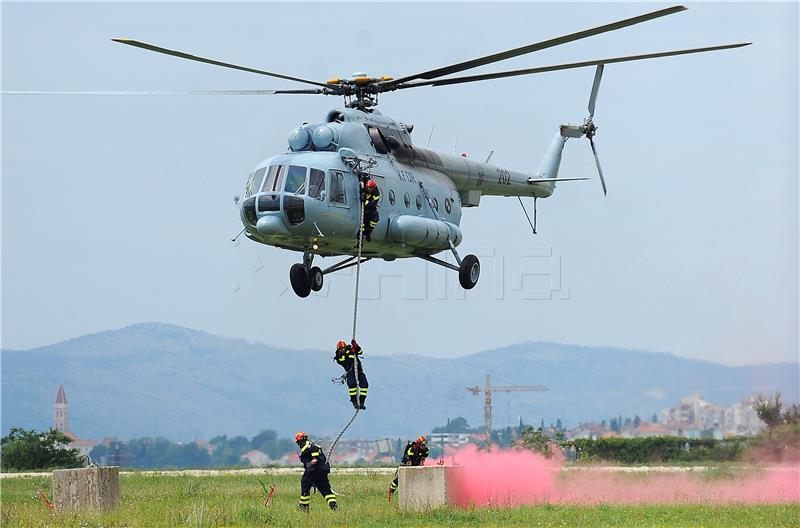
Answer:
2 3 799 364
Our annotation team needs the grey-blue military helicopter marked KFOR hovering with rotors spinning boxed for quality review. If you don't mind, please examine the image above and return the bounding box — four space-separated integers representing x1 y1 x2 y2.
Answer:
10 5 751 297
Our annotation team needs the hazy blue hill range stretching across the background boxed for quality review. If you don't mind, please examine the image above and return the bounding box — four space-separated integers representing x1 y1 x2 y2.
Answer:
2 323 798 440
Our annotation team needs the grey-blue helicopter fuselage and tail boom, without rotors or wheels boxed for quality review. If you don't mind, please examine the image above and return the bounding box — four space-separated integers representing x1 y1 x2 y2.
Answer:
240 108 563 260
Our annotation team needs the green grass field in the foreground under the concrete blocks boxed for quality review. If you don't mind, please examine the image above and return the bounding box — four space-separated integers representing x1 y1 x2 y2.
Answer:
0 473 800 528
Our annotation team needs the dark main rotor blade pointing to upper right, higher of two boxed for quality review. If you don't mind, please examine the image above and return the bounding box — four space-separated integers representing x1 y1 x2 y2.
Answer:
387 6 686 86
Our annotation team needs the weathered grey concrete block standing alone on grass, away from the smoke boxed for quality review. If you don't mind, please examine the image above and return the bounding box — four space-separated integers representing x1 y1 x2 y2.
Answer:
53 467 120 510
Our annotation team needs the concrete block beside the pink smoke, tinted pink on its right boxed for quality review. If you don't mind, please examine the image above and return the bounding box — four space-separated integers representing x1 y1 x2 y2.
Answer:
397 465 462 511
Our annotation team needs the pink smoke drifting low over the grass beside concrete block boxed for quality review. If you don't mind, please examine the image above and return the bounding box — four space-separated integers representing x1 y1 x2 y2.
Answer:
438 446 800 507
